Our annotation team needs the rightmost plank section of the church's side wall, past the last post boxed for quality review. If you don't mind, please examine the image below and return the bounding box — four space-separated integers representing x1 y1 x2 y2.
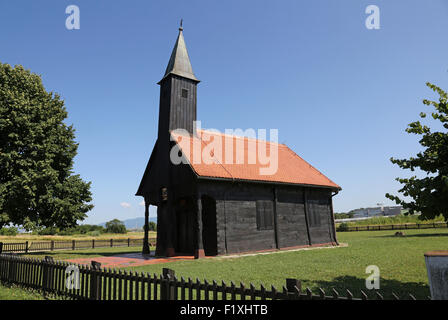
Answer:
306 188 335 244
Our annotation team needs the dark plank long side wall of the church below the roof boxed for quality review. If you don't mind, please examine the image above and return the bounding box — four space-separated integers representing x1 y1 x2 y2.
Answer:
198 181 334 254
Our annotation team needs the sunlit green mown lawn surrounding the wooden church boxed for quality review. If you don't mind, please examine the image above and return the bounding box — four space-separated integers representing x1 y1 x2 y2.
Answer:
6 229 448 299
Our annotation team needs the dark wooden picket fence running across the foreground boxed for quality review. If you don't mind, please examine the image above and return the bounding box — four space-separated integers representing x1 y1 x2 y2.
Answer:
0 254 426 300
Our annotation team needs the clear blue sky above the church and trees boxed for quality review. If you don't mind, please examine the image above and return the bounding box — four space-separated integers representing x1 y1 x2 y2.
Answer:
0 0 448 223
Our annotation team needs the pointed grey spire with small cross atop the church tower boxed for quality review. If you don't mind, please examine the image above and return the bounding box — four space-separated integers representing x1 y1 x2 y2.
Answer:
162 19 199 82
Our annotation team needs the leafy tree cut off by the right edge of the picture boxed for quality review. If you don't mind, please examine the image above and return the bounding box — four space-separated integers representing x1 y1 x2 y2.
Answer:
386 83 448 221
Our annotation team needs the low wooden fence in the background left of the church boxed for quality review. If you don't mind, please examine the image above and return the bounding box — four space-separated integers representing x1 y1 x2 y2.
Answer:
0 238 156 253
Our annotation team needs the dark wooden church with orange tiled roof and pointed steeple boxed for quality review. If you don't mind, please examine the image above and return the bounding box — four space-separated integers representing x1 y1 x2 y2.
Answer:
136 26 341 258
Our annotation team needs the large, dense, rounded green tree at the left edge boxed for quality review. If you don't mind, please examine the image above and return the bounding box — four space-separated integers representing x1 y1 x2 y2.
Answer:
0 63 93 230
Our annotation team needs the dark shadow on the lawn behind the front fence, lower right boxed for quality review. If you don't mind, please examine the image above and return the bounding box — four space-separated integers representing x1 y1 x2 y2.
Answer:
302 276 430 300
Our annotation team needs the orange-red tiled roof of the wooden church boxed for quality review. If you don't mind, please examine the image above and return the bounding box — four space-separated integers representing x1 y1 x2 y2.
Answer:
171 130 341 189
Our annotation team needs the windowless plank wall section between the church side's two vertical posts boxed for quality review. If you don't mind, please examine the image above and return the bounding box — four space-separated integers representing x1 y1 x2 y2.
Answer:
277 187 309 248
